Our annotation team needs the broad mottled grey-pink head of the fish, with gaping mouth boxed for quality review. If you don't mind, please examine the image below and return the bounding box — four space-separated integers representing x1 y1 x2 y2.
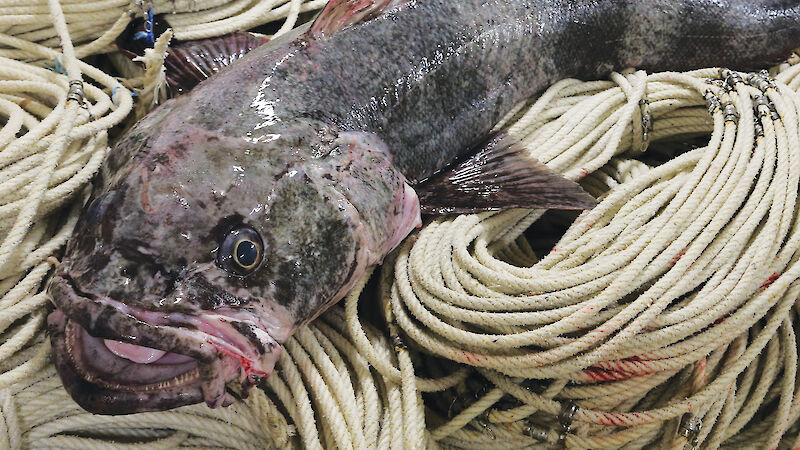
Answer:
47 99 419 414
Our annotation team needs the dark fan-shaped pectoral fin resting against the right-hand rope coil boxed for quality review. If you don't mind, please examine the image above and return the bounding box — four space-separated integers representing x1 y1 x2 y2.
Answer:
414 134 597 214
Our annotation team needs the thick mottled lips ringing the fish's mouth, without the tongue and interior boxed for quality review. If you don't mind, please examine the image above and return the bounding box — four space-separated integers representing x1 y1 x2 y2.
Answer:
47 270 281 414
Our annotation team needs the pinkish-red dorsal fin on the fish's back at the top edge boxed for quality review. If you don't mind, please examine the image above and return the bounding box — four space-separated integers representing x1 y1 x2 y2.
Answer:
309 0 409 36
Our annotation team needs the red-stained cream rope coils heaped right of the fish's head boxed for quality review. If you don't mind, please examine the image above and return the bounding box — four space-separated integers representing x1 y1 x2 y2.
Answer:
383 66 800 448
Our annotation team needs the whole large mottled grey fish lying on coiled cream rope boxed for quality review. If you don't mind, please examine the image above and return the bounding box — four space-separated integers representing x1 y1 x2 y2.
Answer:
48 0 800 414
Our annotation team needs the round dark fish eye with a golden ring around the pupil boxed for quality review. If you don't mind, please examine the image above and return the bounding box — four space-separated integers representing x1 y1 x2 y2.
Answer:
217 225 264 277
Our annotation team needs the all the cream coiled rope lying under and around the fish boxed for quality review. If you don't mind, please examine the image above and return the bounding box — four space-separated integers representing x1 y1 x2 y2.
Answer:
0 0 800 449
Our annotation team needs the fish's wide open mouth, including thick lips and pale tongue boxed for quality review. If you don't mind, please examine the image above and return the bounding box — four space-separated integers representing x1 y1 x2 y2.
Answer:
48 272 281 415
